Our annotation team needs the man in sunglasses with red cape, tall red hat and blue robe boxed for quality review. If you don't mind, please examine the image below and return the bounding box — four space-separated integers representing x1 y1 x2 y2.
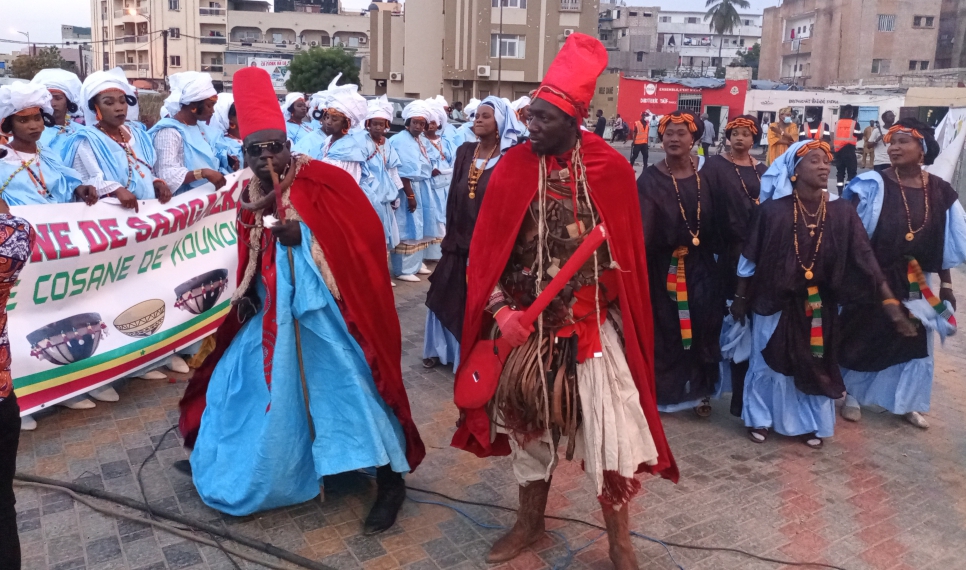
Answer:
180 67 425 534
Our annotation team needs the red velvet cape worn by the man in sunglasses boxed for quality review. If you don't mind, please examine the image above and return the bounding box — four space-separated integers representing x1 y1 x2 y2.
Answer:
179 160 426 470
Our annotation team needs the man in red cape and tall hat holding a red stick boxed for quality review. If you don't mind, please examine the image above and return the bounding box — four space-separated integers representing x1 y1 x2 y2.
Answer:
452 33 678 569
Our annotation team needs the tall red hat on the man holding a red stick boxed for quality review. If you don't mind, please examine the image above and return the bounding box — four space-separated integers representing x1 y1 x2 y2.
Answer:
533 33 607 119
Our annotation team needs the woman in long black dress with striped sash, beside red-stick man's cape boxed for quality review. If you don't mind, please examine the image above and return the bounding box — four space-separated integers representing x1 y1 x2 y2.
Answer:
637 111 724 417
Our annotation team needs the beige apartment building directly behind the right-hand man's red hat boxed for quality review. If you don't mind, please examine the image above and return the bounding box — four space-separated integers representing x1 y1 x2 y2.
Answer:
369 0 598 102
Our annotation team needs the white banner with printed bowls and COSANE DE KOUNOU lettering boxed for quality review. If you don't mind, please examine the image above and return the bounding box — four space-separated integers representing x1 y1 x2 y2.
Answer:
7 170 250 414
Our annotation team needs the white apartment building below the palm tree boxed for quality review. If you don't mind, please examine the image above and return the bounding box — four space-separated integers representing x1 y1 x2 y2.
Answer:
657 10 764 77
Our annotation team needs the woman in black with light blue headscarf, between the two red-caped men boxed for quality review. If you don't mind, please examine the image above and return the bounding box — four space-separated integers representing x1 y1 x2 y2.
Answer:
423 96 523 370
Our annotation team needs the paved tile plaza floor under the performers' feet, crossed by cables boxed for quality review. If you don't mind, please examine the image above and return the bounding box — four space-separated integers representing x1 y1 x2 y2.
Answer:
17 273 966 570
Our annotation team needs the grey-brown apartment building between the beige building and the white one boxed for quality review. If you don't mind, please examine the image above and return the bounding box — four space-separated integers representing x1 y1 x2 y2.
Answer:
597 3 678 77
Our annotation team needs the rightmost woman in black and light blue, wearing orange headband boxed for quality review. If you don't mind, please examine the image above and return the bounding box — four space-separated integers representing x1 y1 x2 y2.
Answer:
842 118 966 429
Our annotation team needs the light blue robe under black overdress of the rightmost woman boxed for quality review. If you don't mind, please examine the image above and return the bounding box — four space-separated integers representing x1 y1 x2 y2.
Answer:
842 172 966 415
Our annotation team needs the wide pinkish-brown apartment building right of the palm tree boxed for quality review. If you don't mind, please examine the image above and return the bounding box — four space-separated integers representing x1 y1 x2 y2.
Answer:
758 0 940 88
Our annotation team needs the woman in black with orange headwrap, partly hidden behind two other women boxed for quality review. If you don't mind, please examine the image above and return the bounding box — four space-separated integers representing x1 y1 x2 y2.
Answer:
701 115 767 417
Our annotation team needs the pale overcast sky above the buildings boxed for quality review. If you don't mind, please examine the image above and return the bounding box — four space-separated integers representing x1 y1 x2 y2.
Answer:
0 0 779 46
